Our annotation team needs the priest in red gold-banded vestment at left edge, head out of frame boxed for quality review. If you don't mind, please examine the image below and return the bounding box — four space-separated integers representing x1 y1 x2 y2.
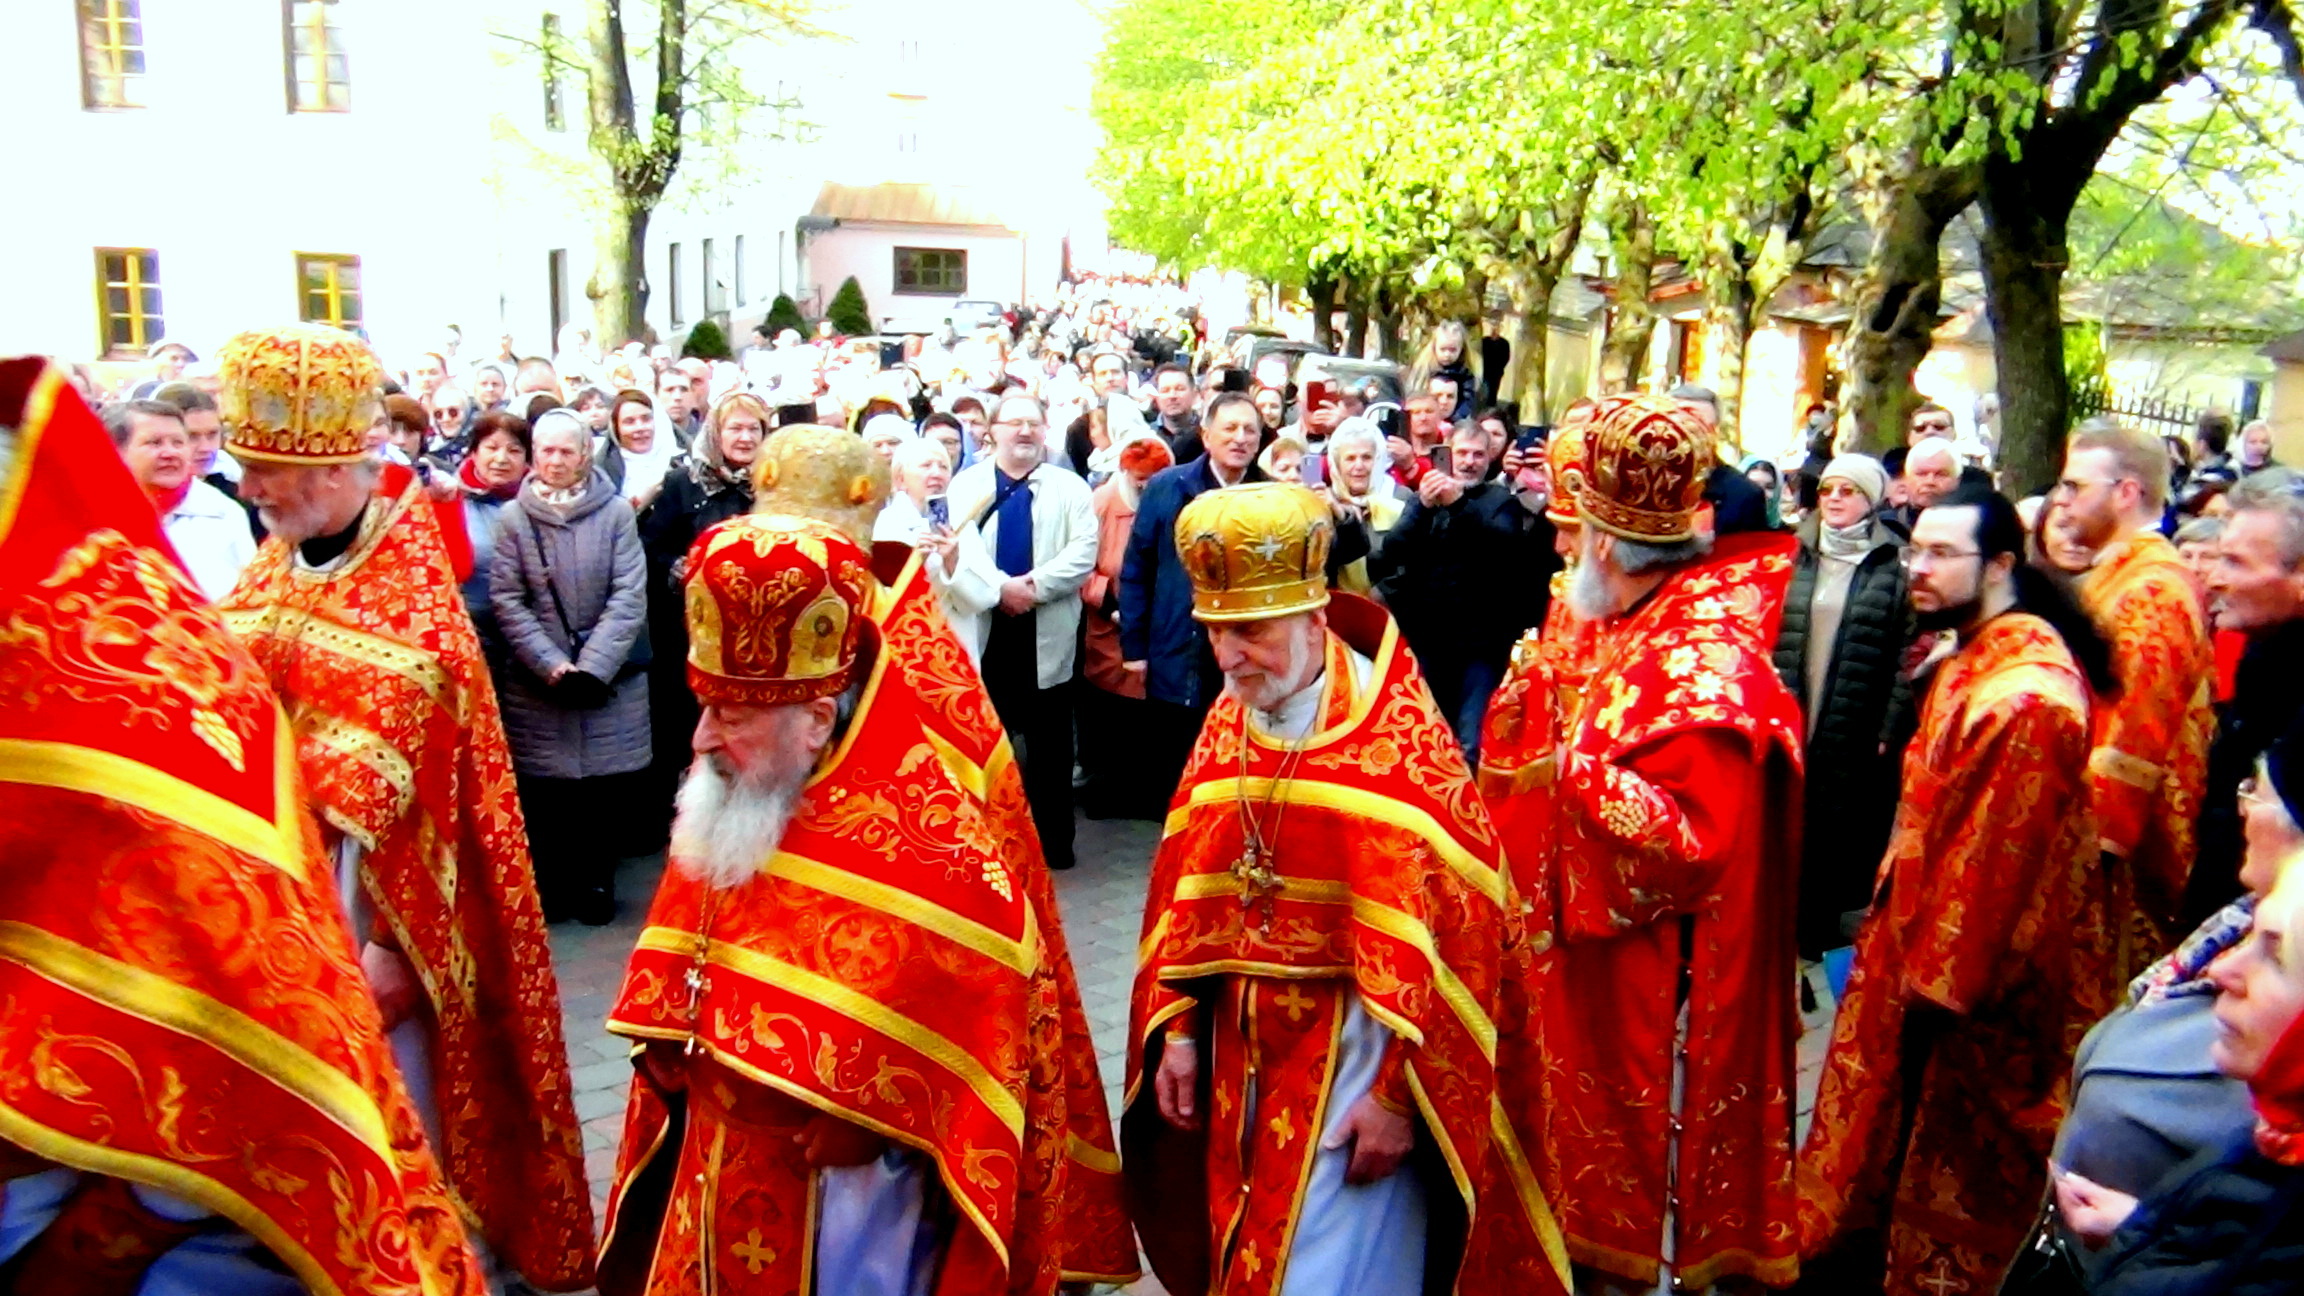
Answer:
0 360 482 1296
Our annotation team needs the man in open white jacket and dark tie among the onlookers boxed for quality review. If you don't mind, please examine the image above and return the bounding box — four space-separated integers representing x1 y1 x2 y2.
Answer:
949 387 1097 869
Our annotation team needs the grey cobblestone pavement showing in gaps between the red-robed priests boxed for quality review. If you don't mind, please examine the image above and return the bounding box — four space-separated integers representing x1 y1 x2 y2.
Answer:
551 819 1832 1296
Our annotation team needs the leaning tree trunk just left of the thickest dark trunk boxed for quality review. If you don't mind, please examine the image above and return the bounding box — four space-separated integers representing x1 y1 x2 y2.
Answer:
1841 166 1977 454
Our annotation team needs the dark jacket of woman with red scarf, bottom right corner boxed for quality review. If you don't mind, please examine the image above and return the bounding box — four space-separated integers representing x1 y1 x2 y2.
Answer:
2087 1134 2304 1296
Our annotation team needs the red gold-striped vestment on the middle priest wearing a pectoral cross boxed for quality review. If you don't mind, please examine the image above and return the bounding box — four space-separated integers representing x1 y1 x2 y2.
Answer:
1122 595 1567 1296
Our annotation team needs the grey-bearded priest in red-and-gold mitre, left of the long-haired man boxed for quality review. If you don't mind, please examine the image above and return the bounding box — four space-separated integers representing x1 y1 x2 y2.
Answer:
1481 397 1799 1289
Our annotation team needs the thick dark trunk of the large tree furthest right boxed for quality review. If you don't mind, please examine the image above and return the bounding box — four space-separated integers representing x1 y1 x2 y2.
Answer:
1977 159 2071 498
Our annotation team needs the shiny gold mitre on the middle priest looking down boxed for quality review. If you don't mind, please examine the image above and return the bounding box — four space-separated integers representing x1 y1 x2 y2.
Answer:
1175 482 1336 620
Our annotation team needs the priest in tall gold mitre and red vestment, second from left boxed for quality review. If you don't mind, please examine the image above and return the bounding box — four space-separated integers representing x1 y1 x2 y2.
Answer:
217 325 592 1291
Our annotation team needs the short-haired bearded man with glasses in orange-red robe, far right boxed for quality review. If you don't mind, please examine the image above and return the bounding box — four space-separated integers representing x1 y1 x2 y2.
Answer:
2055 420 2216 978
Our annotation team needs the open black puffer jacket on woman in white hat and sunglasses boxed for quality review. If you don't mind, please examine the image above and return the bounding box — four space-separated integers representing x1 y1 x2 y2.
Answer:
1776 517 1912 957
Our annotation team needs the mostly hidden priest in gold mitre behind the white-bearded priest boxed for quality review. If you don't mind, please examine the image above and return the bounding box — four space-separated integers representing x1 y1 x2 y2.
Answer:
753 424 1140 1284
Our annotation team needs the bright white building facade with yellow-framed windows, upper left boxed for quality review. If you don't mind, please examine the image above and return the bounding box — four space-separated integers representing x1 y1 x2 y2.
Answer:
0 0 1110 380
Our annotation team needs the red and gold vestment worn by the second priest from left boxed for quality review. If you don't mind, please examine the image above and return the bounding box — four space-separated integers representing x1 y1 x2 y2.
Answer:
223 484 592 1291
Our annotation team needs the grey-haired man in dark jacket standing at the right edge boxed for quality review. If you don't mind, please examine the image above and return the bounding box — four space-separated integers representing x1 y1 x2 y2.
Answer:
2184 468 2304 927
